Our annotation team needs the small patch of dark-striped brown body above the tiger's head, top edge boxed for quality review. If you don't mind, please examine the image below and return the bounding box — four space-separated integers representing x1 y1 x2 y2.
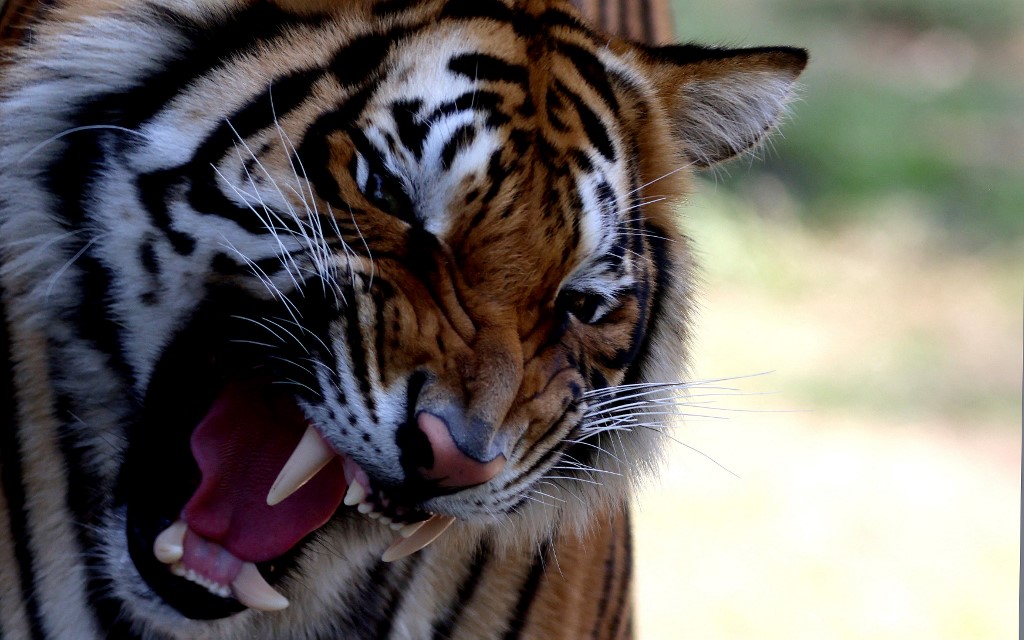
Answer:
572 0 676 44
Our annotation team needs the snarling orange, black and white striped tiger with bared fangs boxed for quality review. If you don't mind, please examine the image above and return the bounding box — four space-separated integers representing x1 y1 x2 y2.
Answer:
0 0 808 639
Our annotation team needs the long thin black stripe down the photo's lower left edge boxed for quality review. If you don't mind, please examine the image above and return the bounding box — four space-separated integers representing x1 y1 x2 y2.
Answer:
0 292 46 640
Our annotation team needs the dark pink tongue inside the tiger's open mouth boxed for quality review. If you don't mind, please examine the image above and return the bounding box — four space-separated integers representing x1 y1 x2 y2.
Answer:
182 382 347 562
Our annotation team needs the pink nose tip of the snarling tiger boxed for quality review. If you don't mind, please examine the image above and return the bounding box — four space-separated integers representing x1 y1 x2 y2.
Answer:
416 412 505 488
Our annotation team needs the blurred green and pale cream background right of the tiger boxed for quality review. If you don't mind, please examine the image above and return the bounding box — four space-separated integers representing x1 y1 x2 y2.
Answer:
636 0 1024 640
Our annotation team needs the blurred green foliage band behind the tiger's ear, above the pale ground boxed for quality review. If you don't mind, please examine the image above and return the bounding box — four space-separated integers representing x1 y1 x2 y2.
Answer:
674 0 1024 246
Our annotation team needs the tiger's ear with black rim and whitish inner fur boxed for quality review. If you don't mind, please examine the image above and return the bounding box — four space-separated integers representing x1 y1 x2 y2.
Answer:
643 45 808 167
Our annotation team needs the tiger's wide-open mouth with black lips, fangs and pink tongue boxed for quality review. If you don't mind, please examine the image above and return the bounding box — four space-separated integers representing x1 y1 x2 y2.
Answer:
121 288 453 620
